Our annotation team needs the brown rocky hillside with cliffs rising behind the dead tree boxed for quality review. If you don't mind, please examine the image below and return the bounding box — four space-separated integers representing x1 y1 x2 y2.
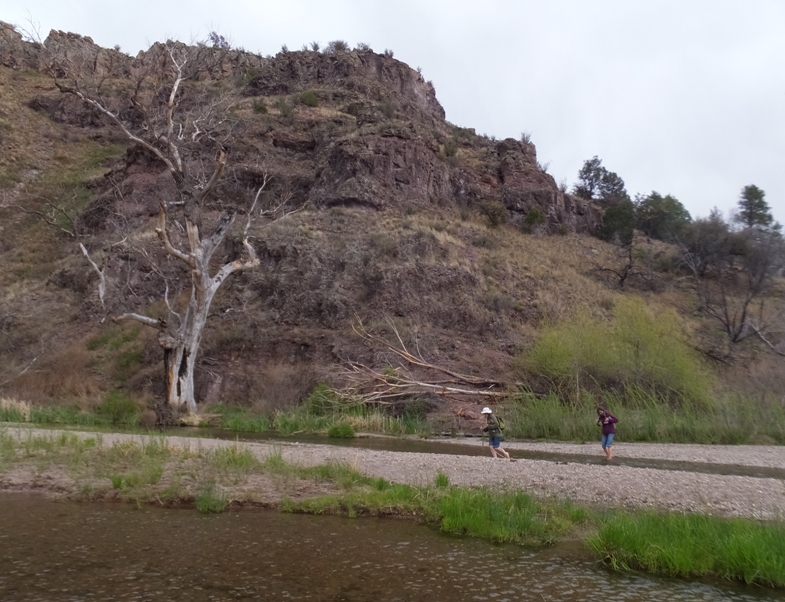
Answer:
0 25 772 418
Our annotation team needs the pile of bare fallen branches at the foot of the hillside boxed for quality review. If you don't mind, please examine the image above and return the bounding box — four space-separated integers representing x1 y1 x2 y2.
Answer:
338 319 509 405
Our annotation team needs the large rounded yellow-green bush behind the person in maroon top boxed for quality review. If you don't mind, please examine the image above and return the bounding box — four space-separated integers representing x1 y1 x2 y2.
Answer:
522 298 712 405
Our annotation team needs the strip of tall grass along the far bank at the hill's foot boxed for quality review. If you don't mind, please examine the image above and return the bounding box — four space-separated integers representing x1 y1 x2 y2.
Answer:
6 389 785 445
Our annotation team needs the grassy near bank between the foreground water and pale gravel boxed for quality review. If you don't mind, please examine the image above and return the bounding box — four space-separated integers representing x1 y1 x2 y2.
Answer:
0 429 785 588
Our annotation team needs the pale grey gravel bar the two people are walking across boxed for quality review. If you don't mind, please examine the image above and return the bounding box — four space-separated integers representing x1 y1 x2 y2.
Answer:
6 428 785 519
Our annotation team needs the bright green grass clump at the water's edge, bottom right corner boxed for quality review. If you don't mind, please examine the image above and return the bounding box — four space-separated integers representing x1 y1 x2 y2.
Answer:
588 511 785 587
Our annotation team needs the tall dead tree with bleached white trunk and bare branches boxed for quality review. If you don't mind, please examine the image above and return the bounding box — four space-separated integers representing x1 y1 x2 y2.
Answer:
43 35 285 420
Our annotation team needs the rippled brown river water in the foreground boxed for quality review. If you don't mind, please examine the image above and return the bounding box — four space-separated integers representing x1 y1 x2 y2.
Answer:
0 494 785 602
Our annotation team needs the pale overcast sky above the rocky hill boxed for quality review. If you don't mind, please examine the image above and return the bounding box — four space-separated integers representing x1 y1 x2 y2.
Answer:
6 0 785 223
